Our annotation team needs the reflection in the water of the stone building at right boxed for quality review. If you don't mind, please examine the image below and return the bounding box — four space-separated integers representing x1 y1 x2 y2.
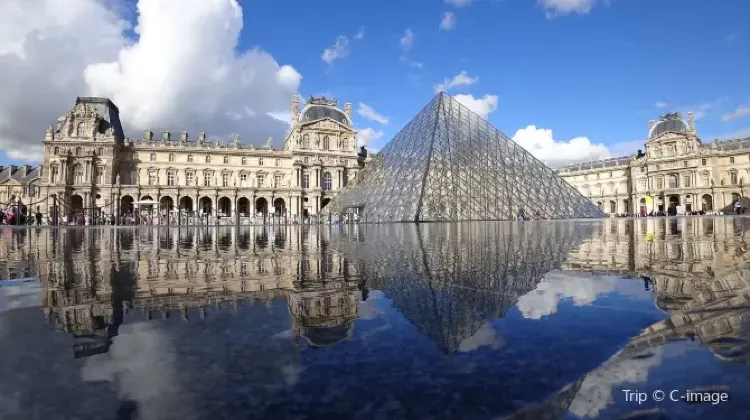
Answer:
565 217 750 359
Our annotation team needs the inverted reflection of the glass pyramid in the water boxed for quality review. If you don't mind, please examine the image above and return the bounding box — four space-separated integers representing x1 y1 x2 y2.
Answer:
335 222 589 353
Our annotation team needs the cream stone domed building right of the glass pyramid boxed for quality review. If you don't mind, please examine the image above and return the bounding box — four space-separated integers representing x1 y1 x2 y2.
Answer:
559 113 750 214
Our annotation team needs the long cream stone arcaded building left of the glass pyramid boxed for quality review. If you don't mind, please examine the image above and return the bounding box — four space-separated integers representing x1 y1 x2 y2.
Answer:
39 95 364 218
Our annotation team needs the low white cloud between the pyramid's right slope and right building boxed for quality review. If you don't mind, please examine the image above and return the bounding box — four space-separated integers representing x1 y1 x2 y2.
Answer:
513 125 612 167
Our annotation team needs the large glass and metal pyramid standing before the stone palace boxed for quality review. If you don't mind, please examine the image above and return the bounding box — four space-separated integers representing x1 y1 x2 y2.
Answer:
326 92 605 222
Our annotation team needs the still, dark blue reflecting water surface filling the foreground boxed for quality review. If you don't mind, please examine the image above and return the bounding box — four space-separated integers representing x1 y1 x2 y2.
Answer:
0 217 750 420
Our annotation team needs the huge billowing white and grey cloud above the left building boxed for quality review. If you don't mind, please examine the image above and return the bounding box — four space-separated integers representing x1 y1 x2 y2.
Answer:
0 0 301 161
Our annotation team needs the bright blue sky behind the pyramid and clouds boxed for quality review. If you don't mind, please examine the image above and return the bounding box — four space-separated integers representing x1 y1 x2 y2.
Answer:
0 0 750 167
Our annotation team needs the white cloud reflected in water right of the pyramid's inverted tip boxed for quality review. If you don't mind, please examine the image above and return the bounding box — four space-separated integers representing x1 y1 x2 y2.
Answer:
516 271 615 319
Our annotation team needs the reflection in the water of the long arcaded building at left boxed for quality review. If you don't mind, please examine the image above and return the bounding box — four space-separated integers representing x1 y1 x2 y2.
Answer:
8 227 357 355
